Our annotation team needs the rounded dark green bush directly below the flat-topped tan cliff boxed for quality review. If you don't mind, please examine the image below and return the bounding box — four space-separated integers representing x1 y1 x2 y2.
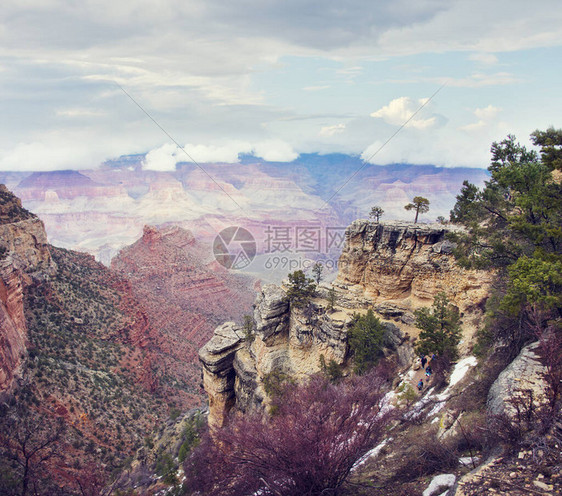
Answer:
348 309 385 374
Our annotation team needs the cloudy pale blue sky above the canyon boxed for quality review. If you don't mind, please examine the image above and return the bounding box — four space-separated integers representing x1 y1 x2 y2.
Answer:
0 0 562 171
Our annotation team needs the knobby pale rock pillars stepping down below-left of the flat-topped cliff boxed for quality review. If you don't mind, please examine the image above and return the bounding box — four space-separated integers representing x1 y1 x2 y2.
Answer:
199 284 413 427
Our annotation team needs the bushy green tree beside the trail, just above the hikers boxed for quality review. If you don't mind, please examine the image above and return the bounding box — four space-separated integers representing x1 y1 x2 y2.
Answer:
416 293 461 361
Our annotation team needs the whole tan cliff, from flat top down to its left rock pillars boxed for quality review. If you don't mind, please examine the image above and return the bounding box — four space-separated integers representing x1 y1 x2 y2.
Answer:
199 221 491 426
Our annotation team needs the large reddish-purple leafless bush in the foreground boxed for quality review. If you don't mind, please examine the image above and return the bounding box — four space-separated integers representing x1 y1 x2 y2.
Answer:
185 372 392 496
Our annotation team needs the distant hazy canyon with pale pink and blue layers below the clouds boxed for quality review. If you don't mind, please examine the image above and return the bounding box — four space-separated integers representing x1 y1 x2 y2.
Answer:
0 154 487 283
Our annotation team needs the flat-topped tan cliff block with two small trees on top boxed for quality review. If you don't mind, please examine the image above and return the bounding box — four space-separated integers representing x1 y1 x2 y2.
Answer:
335 220 493 346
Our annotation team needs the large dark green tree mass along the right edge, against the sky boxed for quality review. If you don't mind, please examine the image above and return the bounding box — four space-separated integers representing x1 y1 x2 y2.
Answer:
451 128 562 350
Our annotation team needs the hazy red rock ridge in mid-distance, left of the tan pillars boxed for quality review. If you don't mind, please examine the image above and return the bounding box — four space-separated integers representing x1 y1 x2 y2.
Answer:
111 226 255 408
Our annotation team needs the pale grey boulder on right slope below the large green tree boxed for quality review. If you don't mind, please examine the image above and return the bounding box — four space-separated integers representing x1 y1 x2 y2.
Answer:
487 343 548 416
